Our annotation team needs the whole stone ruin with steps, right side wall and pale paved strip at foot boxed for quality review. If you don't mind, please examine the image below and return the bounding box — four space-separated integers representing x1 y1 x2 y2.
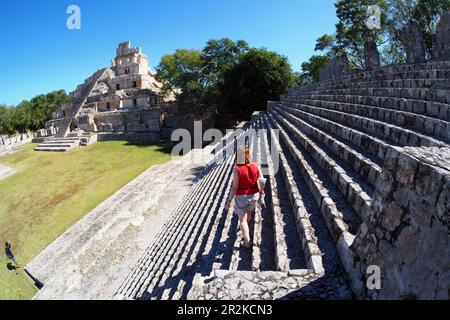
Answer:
23 61 450 300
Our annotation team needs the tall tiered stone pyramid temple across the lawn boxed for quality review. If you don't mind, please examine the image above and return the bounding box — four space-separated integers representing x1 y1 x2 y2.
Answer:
36 41 175 151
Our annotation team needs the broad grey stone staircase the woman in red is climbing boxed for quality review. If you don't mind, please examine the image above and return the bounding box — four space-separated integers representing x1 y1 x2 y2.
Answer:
111 62 450 299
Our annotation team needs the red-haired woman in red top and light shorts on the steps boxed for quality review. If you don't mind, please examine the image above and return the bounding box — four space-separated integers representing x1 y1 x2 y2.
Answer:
225 147 266 248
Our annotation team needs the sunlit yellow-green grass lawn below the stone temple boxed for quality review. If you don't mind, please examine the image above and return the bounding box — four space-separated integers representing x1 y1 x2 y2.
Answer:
0 142 170 299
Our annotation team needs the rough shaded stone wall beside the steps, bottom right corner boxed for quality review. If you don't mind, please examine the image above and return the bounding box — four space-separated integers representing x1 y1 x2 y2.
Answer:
346 147 450 299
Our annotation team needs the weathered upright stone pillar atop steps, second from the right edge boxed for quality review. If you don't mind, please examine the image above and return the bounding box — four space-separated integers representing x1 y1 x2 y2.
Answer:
403 21 426 63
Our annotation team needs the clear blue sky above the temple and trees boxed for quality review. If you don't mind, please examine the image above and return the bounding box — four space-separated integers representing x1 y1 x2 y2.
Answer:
0 0 337 105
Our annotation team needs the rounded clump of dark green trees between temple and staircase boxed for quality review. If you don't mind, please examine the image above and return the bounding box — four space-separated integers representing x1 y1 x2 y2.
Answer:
157 38 300 119
